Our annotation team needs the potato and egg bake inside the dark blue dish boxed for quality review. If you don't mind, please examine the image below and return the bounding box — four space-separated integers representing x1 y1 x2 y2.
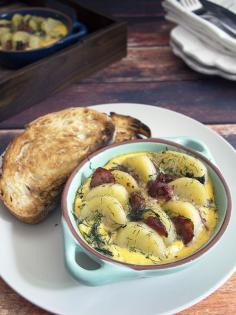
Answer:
0 13 68 51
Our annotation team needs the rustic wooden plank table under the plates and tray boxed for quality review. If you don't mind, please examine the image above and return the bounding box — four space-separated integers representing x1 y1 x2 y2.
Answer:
0 0 236 315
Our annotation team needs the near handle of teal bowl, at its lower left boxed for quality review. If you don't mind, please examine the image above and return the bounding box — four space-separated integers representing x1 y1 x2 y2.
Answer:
62 218 138 286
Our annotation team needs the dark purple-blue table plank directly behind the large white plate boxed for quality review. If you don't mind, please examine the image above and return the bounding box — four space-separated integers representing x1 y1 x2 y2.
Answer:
0 79 236 129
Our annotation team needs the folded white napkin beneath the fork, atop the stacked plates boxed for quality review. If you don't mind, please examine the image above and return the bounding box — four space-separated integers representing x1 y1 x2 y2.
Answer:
162 0 236 56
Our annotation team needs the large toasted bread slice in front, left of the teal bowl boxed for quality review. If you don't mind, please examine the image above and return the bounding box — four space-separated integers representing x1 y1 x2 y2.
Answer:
0 108 115 223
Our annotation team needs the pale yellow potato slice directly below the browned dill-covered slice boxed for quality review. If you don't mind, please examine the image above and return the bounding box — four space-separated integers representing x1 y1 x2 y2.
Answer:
170 177 208 206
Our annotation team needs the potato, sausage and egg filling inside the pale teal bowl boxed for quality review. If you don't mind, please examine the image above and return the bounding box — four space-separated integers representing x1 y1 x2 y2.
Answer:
74 150 218 265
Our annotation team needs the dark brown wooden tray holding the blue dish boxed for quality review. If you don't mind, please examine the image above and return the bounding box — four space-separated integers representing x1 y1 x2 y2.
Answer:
0 0 127 121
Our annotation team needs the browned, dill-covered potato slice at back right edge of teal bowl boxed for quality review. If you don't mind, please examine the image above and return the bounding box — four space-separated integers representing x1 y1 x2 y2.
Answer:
154 151 207 183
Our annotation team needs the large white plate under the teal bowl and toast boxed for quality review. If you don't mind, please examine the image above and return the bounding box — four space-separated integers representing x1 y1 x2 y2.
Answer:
0 104 236 315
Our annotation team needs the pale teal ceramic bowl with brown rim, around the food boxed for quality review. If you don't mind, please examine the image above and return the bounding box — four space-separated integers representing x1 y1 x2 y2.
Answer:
62 137 231 286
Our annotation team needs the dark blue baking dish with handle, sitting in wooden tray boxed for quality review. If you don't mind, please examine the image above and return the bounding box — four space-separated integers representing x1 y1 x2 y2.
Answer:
0 7 88 68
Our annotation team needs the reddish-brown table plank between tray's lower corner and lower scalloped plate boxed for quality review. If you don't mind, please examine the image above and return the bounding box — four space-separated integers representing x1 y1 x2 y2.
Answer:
83 47 201 83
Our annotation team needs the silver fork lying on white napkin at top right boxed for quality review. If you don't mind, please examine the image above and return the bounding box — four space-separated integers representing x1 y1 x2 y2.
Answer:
179 0 236 37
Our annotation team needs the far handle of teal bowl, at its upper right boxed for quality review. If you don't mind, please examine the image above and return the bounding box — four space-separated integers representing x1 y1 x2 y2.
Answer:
165 136 215 164
